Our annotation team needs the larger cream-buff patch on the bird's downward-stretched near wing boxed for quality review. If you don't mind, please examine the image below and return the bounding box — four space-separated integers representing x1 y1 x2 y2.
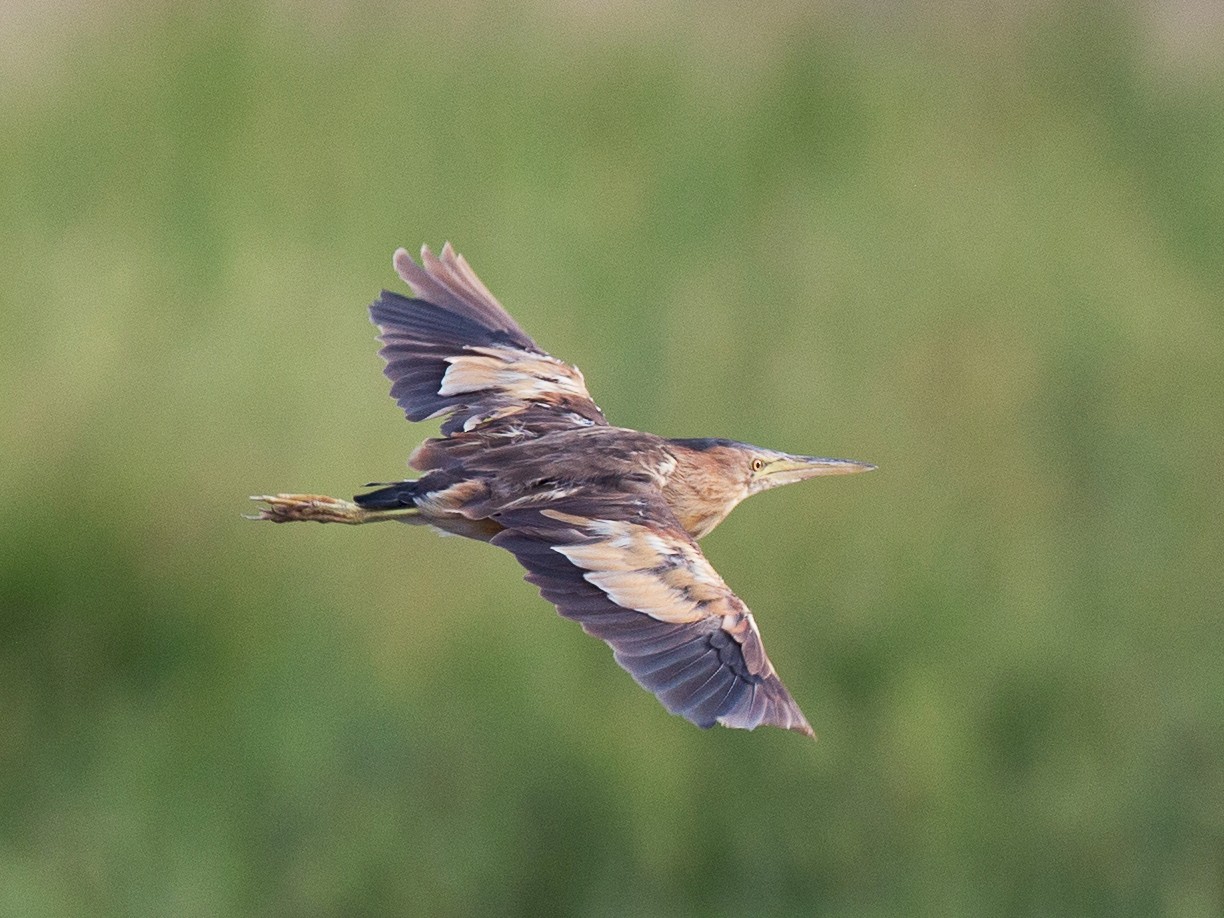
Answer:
553 510 743 624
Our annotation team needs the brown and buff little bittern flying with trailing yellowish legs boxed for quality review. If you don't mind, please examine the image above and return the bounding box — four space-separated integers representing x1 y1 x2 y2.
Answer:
252 244 875 736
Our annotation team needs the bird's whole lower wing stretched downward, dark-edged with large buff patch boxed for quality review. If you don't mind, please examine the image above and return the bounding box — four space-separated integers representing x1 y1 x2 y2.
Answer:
492 494 813 736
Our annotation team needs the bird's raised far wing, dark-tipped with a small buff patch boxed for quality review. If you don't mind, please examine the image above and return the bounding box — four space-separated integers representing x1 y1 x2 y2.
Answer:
370 242 607 436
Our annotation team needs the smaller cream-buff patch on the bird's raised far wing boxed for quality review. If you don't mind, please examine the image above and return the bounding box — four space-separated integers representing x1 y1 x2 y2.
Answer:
438 346 590 401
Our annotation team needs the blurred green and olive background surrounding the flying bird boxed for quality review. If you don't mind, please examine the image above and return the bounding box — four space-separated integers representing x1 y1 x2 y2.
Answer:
0 0 1224 916
